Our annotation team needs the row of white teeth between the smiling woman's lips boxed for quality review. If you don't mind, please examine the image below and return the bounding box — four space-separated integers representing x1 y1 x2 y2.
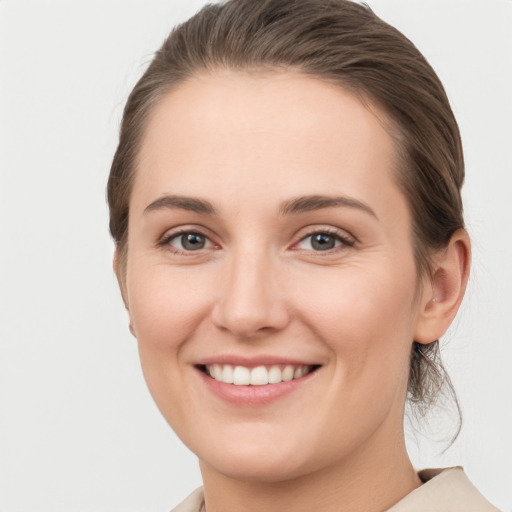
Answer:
198 364 320 386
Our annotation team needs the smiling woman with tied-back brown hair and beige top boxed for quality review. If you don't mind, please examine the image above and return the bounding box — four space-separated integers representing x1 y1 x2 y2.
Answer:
108 0 496 512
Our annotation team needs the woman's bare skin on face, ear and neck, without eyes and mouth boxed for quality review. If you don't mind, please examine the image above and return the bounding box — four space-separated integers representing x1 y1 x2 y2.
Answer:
118 71 469 512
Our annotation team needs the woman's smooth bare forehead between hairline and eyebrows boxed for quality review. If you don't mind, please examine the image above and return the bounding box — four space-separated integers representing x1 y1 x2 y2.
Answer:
132 70 404 220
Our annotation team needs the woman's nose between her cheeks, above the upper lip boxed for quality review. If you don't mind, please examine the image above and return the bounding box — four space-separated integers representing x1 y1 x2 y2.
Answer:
212 251 290 340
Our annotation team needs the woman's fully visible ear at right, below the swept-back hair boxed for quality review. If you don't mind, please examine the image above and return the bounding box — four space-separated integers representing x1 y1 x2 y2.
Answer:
414 229 471 344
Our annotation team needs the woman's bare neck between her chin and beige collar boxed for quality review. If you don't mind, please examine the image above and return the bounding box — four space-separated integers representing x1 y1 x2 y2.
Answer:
200 434 421 512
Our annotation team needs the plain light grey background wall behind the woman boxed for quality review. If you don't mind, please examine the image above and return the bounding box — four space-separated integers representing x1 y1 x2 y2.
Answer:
0 0 512 512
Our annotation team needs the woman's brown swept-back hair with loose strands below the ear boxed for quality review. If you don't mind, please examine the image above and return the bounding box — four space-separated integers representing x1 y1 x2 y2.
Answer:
108 0 464 428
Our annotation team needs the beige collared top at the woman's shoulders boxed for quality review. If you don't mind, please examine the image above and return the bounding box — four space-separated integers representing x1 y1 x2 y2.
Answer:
171 467 500 512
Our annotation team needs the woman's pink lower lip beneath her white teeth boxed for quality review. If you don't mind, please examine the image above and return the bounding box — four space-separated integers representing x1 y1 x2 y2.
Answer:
197 369 318 407
